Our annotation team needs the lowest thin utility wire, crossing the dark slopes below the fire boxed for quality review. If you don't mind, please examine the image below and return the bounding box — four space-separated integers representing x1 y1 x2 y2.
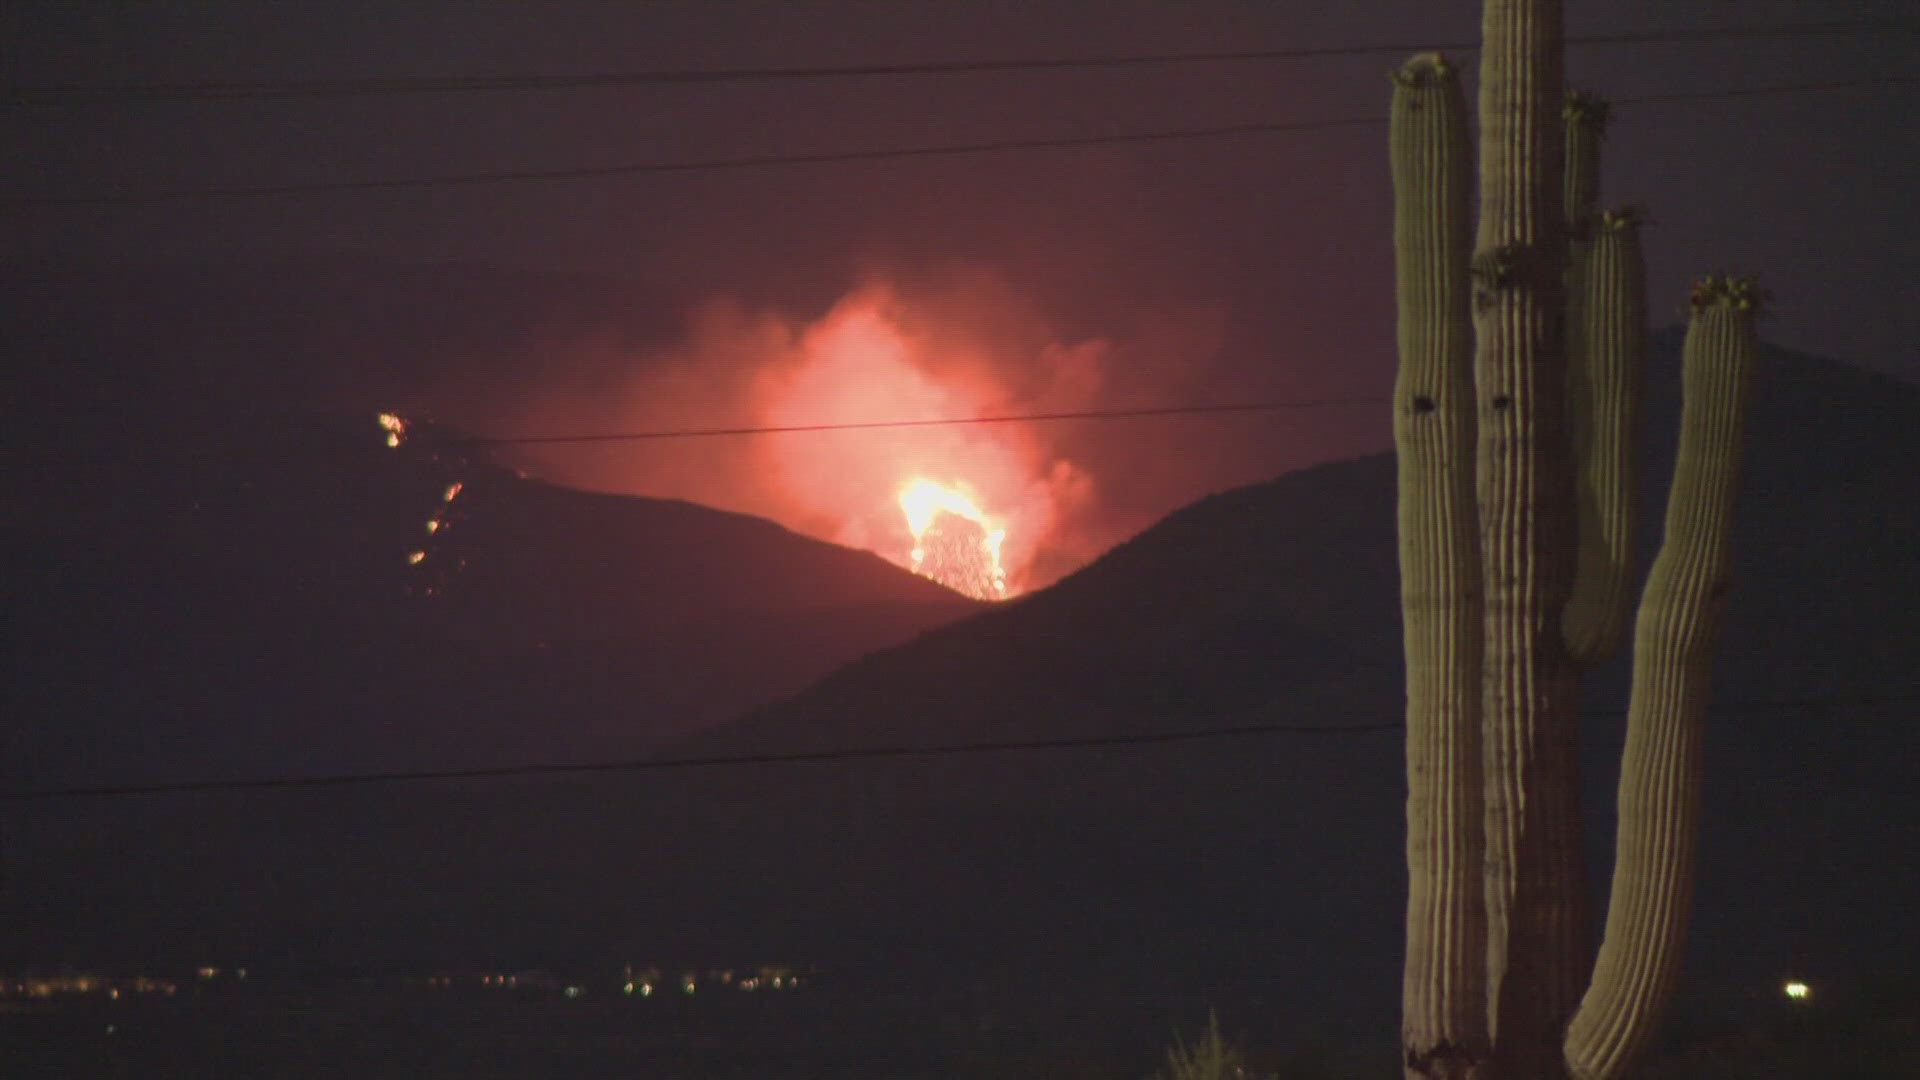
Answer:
0 694 1920 803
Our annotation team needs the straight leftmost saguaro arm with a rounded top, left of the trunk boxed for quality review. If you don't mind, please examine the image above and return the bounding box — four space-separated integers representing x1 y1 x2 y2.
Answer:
1388 54 1488 1080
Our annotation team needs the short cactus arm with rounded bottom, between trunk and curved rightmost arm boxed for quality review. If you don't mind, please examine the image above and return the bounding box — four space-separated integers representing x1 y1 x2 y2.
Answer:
1561 208 1647 665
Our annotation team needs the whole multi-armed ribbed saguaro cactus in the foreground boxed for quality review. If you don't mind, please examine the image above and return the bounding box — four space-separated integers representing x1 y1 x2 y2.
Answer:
1390 0 1755 1080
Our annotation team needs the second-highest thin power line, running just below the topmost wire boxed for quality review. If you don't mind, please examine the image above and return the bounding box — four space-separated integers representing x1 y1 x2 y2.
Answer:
0 75 1920 209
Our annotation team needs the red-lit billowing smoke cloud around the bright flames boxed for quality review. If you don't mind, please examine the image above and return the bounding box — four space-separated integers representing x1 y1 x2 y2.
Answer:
487 265 1210 596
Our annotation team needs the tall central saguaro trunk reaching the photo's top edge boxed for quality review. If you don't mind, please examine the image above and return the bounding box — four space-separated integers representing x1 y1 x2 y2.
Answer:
1473 0 1588 1078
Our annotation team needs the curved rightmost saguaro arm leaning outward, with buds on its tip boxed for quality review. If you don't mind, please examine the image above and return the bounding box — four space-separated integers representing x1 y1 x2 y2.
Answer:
1565 279 1757 1080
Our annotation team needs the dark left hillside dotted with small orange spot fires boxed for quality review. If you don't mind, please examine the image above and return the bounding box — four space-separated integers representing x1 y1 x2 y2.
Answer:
0 405 975 786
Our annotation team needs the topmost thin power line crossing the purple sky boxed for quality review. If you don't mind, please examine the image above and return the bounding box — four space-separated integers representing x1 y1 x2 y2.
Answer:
0 19 1912 106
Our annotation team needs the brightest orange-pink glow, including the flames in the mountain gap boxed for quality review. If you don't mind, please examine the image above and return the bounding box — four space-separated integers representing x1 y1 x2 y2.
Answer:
751 286 1089 600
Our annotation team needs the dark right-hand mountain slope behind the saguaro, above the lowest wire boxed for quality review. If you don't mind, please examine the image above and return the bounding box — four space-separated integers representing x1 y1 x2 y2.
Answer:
706 320 1920 746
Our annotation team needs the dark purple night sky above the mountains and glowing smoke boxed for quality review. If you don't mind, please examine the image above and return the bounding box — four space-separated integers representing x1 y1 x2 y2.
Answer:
0 0 1920 564
